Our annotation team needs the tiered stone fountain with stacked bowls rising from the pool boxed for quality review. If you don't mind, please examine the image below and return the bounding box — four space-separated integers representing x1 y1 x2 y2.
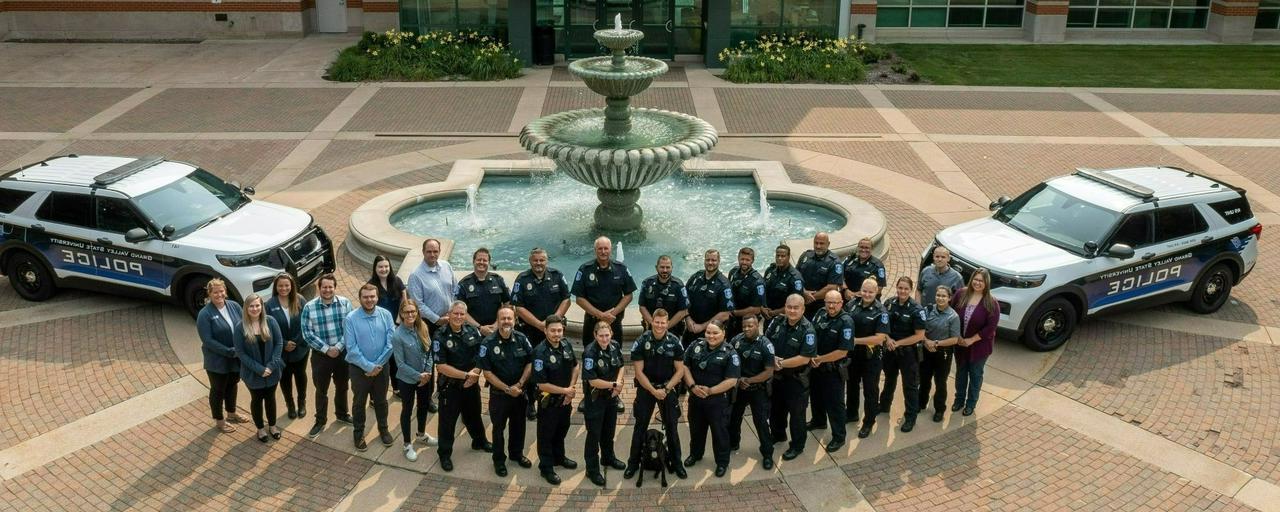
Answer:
520 15 717 232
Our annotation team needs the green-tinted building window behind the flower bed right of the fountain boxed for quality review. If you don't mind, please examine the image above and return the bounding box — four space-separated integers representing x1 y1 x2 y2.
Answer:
728 0 840 45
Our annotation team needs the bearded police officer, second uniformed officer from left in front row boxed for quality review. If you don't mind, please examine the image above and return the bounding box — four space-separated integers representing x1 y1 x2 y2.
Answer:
476 306 534 476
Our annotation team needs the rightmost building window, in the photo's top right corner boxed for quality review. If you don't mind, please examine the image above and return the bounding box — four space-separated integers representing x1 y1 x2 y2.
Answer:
1066 0 1208 28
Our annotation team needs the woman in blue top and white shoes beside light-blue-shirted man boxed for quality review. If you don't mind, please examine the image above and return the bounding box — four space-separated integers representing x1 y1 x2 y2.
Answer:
392 298 436 462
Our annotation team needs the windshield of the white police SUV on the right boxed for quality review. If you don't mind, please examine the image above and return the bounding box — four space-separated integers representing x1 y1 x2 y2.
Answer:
995 183 1120 255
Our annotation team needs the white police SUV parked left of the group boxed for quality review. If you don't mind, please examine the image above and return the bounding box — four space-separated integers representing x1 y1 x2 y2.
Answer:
0 155 335 315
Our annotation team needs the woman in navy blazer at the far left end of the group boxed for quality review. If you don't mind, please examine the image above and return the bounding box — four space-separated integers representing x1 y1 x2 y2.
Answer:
196 279 244 434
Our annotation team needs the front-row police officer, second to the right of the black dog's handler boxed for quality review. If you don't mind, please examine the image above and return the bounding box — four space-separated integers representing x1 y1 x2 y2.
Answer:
728 315 774 471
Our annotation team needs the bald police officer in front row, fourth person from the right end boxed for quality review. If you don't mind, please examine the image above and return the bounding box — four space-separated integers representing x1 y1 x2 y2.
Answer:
846 279 888 438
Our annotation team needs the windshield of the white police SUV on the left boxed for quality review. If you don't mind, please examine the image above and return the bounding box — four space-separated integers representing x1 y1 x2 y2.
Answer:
134 169 248 238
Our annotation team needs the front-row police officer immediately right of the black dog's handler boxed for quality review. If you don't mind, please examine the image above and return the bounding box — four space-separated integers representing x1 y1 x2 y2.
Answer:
685 320 742 477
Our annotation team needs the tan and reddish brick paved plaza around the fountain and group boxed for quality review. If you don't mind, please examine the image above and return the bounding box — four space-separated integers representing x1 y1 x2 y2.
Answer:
0 37 1280 511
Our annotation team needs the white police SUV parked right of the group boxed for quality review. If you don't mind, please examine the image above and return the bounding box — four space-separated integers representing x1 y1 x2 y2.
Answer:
920 166 1262 351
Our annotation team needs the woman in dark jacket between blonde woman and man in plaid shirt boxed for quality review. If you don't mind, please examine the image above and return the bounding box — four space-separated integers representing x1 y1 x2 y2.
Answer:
266 273 311 420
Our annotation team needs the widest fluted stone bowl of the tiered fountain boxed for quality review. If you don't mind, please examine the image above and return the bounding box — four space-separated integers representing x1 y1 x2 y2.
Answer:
520 109 718 191
